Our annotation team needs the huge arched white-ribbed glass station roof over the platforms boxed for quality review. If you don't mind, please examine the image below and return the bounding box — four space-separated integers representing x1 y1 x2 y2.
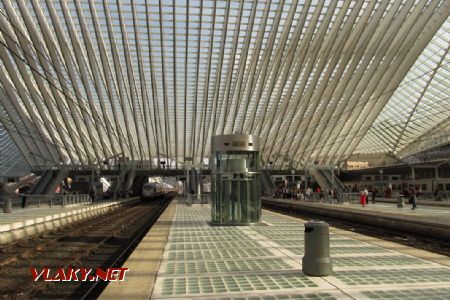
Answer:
0 0 450 172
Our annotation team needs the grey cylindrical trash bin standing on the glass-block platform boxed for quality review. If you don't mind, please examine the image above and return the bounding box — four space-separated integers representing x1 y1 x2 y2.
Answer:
302 221 333 276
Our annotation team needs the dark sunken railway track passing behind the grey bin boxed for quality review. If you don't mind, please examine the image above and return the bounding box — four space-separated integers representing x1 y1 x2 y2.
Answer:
263 201 450 256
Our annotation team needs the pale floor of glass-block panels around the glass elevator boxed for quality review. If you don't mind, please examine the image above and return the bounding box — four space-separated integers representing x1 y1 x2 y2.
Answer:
152 204 450 300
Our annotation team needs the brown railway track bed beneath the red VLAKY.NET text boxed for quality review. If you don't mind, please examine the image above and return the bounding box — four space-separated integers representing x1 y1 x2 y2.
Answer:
0 199 174 299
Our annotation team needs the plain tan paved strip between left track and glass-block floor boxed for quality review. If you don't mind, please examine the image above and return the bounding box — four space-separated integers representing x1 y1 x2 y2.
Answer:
100 201 176 299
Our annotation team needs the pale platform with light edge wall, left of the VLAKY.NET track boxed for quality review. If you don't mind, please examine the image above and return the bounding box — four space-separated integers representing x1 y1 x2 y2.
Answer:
0 197 139 245
